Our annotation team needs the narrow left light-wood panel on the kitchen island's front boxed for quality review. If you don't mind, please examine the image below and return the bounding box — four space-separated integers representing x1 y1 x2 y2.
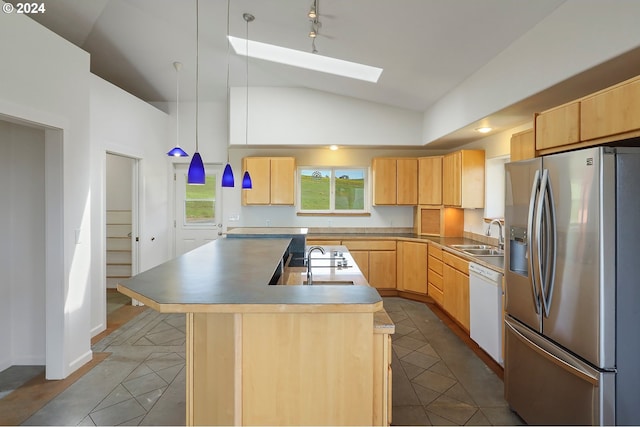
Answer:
186 313 242 425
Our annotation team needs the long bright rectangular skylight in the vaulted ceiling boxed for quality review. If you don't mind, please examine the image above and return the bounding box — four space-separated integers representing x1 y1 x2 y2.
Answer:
227 36 382 83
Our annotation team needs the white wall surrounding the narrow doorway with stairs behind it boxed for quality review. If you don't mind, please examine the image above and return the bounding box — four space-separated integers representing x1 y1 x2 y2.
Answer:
90 75 175 335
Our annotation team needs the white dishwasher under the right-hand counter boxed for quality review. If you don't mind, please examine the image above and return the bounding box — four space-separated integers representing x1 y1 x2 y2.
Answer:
469 262 503 365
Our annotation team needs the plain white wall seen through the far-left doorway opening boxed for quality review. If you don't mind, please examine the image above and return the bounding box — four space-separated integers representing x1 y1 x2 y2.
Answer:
0 121 45 371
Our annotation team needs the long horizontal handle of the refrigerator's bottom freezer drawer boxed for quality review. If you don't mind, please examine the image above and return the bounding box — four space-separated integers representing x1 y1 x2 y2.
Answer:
505 319 600 387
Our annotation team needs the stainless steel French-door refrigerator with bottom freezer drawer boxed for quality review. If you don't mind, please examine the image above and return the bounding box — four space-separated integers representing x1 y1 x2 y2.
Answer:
504 147 640 425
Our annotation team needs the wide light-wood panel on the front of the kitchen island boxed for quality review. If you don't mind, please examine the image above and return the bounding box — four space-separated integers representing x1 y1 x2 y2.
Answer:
242 313 374 425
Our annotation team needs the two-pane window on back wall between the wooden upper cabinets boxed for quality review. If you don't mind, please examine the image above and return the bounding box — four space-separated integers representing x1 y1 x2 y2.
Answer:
298 167 368 213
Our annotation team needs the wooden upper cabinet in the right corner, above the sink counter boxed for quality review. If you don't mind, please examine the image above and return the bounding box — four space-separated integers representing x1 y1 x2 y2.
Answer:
442 150 484 209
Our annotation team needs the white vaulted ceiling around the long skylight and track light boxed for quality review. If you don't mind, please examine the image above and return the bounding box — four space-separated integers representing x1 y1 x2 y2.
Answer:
11 0 640 149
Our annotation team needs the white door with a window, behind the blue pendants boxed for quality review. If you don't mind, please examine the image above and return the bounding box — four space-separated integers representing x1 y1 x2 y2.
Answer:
174 164 222 256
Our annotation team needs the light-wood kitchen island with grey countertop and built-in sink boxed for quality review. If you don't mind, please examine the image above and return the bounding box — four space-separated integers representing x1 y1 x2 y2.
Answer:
118 238 393 425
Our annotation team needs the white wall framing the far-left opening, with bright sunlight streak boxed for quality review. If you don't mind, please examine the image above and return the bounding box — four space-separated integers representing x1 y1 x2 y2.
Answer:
0 8 91 379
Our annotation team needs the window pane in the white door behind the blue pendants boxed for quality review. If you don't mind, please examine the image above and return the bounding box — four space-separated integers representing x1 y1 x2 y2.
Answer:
184 175 216 225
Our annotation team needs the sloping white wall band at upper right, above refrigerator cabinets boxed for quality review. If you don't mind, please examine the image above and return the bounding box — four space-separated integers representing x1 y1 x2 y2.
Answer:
422 0 640 144
